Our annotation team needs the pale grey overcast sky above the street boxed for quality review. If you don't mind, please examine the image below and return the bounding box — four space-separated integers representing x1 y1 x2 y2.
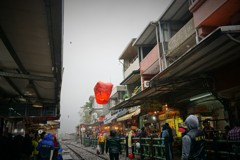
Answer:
60 0 170 133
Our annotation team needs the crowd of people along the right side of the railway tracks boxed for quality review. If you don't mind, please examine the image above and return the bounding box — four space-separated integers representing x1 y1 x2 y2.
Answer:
93 115 240 160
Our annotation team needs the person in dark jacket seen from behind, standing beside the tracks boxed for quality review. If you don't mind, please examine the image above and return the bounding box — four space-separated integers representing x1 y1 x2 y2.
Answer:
106 130 122 160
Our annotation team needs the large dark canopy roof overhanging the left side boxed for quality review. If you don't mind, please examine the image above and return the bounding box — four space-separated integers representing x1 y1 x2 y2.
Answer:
0 0 63 119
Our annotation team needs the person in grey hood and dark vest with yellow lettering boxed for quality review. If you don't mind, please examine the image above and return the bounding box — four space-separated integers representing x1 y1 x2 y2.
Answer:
181 115 206 160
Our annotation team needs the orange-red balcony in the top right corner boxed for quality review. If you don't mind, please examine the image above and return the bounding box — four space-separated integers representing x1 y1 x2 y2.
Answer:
189 0 240 37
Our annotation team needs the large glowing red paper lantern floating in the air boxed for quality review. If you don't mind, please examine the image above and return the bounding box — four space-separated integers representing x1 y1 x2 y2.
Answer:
94 81 113 104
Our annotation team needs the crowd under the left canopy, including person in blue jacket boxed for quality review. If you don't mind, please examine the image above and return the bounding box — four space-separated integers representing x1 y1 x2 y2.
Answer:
0 130 62 160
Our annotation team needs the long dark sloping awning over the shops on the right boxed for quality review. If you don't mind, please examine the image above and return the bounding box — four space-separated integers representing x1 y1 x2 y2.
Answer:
111 25 240 110
